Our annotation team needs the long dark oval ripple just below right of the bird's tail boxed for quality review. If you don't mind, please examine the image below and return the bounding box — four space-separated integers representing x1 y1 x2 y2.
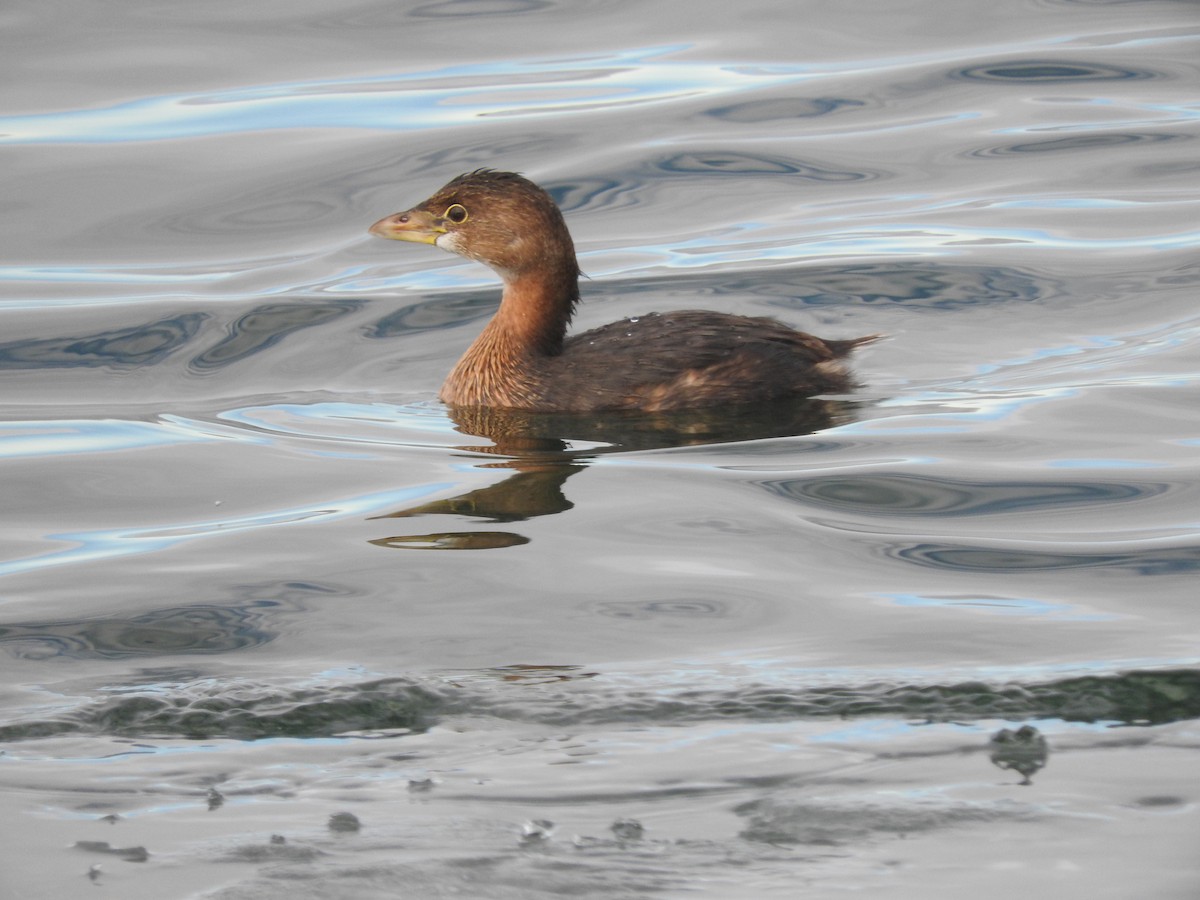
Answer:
761 475 1171 516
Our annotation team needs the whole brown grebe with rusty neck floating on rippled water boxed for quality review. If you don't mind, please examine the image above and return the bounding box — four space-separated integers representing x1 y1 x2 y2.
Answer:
371 169 874 413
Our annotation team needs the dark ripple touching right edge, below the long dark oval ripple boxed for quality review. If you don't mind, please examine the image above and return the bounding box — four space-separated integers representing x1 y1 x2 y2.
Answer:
887 541 1200 575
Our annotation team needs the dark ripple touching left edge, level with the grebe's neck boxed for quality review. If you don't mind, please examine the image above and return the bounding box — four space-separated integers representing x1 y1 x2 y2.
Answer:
0 312 209 370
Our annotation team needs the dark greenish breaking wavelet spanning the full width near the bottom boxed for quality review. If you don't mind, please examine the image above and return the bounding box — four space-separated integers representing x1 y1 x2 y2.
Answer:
0 670 1200 740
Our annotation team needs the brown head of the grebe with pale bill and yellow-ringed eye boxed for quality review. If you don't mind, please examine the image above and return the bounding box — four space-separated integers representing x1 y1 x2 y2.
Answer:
371 169 578 281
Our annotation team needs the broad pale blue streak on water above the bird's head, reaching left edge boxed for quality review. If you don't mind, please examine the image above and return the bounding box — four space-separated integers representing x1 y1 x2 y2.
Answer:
0 46 825 144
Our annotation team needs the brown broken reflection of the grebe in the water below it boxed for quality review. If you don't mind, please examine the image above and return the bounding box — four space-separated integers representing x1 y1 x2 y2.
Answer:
371 398 853 550
